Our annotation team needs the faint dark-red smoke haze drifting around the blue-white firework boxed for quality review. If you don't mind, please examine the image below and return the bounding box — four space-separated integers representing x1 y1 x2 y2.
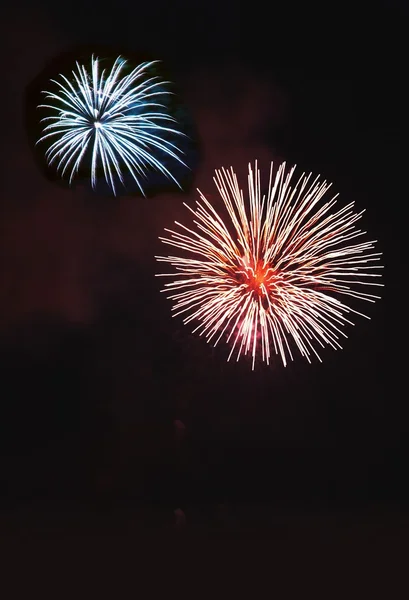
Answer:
0 12 285 327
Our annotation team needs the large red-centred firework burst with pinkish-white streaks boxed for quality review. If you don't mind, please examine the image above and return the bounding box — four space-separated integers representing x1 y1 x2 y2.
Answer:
156 163 382 369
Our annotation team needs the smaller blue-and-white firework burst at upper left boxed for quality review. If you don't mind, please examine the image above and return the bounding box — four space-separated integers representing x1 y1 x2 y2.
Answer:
37 56 187 195
